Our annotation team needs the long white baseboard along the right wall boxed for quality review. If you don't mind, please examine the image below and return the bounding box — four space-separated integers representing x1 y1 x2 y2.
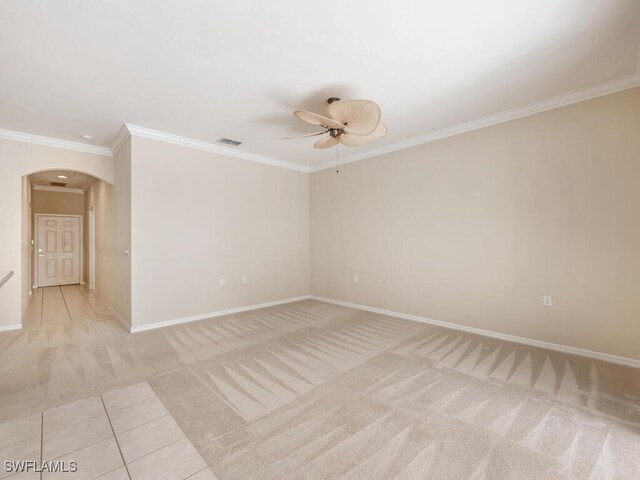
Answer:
310 295 640 368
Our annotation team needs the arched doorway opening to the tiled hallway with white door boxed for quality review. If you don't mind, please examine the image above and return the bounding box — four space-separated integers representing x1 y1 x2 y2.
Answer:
22 169 113 328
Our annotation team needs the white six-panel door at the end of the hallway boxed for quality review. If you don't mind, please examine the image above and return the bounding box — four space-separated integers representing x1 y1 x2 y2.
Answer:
37 215 81 287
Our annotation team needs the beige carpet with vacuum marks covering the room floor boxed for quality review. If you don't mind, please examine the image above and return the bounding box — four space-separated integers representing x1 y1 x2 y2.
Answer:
0 301 640 480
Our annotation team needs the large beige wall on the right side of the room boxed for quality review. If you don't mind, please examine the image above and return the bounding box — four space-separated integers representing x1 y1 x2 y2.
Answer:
311 88 640 359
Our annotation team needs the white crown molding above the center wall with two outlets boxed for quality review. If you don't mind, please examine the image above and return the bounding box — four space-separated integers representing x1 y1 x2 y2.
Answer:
125 123 309 173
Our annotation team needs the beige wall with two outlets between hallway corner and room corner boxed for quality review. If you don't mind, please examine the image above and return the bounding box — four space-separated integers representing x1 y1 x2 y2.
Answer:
131 137 309 326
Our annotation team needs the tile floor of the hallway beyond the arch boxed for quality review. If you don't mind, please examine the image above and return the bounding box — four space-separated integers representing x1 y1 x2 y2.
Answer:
23 285 111 327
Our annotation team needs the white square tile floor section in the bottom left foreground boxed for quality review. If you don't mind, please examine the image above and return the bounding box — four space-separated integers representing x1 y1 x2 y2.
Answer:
0 382 216 480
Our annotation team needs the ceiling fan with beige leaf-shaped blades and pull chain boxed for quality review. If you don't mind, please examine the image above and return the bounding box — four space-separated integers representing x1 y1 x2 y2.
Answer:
289 97 387 148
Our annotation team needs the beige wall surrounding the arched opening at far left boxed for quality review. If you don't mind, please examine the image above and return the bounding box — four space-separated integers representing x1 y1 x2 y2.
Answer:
0 139 114 329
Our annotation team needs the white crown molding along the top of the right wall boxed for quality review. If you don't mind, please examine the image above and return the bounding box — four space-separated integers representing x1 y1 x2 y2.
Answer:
309 73 640 173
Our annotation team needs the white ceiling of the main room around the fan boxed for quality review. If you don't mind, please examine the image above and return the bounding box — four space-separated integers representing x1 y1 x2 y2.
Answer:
0 0 640 165
